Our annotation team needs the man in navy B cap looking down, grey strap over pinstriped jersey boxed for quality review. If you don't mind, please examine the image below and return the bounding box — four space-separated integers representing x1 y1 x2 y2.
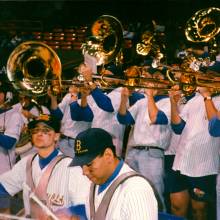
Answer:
70 128 158 220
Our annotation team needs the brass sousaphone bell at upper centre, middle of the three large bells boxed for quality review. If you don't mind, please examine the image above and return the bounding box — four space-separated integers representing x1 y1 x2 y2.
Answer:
82 15 123 65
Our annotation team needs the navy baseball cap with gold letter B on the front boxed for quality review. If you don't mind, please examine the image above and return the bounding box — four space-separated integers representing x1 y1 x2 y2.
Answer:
70 128 113 166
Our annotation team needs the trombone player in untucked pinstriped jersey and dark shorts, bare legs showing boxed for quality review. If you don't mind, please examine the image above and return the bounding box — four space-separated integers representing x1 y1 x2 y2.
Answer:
170 84 220 219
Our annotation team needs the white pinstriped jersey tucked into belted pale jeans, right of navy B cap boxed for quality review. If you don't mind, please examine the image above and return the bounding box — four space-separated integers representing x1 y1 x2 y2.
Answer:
128 97 171 149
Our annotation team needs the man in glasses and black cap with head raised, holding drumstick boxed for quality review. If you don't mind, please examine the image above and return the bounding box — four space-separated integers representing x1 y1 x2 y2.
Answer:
0 115 89 220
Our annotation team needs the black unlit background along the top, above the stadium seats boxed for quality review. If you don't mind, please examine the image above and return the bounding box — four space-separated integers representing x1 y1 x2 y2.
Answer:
0 0 220 28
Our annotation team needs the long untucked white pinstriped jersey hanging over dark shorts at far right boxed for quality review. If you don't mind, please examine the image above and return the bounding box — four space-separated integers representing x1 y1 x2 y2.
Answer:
173 94 220 177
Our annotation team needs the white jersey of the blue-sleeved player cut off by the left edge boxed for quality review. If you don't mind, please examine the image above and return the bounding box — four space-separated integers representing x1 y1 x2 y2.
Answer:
0 109 23 174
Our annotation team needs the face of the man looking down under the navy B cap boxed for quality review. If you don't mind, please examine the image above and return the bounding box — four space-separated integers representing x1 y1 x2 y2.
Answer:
82 151 108 185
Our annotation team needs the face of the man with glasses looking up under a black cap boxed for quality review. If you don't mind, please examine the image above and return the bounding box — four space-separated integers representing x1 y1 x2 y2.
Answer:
31 123 59 149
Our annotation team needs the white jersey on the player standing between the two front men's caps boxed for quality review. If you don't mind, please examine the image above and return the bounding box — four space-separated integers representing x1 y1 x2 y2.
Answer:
58 93 91 138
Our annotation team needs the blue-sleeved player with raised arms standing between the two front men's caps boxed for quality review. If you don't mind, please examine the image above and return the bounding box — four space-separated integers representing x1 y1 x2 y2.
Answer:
48 86 93 157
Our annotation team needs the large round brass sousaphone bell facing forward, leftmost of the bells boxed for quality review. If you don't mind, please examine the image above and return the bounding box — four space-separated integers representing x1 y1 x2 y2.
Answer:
7 41 61 96
